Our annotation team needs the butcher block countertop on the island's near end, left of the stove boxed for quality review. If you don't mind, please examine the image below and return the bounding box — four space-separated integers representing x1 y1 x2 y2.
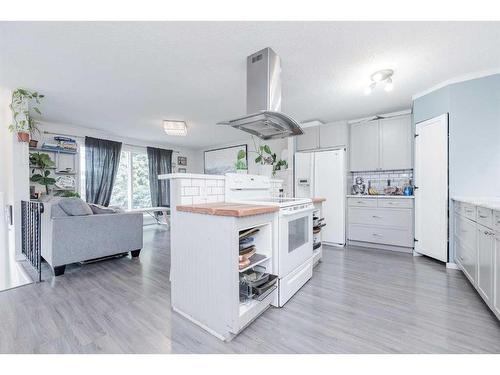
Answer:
177 202 279 217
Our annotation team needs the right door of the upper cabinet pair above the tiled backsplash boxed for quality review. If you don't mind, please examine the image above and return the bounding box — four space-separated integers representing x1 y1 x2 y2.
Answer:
380 116 412 170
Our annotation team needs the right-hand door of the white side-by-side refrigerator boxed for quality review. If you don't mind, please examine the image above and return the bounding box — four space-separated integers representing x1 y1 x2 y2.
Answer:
314 149 346 245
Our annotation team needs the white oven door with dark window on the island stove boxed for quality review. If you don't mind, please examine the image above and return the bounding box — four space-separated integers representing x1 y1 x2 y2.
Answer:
278 206 314 277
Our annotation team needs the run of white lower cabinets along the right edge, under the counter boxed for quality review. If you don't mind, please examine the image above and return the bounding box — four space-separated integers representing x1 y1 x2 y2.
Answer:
453 200 500 319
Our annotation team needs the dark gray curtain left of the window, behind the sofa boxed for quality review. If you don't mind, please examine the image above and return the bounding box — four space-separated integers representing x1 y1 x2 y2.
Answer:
85 137 122 206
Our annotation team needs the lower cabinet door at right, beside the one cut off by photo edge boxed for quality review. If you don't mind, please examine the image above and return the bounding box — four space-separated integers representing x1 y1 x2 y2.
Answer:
477 225 495 303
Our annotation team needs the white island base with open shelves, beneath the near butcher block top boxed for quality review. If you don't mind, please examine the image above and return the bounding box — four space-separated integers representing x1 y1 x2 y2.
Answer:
171 211 278 340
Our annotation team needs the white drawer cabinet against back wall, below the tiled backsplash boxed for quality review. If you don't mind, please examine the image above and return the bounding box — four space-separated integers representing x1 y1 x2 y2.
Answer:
347 197 414 252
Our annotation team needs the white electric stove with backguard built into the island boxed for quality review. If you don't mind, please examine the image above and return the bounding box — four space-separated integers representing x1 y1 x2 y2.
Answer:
225 174 314 307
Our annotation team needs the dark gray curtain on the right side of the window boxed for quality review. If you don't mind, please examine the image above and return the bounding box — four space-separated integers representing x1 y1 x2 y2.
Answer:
147 147 172 207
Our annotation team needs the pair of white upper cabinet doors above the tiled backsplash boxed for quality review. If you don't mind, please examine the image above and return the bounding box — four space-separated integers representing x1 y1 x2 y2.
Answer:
350 115 413 171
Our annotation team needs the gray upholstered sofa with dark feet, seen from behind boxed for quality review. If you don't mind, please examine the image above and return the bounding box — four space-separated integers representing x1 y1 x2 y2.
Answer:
41 198 143 276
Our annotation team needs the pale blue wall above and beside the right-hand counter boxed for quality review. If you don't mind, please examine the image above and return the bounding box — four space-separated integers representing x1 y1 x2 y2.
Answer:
413 74 500 262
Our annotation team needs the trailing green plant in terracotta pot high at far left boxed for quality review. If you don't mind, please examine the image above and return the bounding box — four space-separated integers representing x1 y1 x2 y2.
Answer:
9 88 44 142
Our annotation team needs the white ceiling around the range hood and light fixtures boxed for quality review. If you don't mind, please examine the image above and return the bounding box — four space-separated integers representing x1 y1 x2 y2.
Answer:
0 22 500 148
